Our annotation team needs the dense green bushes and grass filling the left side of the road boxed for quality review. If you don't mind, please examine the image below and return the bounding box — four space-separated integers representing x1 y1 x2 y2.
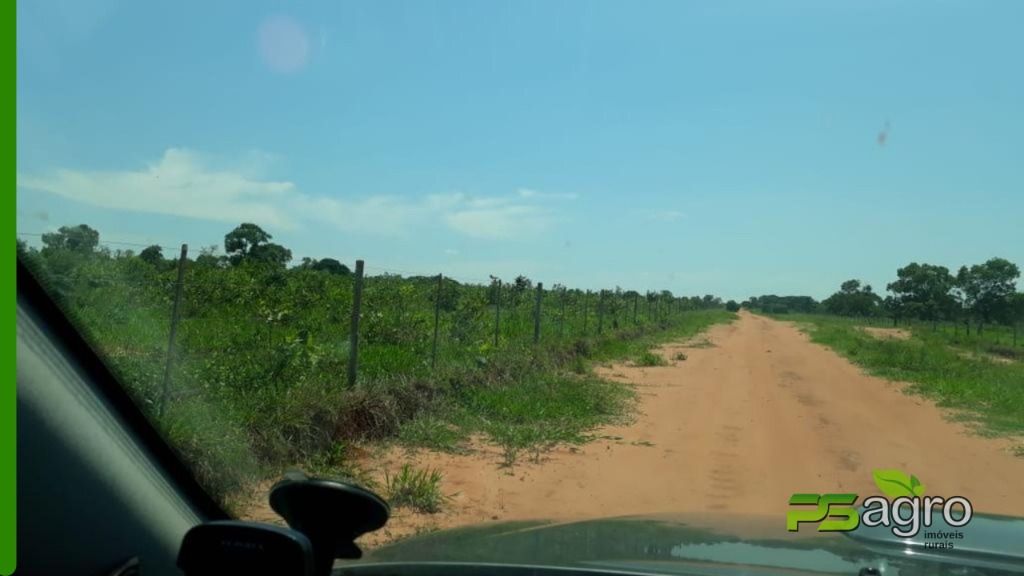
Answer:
18 223 734 508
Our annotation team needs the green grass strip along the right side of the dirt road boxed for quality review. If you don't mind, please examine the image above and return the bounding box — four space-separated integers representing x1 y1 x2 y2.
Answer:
779 315 1024 436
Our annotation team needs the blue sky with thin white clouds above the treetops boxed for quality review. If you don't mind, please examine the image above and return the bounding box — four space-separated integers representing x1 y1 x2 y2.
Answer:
17 0 1024 299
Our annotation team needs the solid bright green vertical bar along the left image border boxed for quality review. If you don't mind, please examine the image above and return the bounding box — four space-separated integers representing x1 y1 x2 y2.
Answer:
0 2 17 576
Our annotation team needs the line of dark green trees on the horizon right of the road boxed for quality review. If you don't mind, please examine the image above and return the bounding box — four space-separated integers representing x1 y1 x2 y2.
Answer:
741 257 1024 334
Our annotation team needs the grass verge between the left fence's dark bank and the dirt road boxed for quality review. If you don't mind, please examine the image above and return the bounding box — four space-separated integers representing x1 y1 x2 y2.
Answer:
387 311 735 461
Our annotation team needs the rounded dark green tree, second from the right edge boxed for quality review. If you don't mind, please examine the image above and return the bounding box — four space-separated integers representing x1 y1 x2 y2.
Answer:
887 262 956 321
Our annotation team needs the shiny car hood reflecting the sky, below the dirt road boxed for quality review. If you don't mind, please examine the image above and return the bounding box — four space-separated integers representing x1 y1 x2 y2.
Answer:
360 508 1024 576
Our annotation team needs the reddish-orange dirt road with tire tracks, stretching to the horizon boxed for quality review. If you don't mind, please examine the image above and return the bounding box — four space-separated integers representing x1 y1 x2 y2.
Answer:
241 313 1024 544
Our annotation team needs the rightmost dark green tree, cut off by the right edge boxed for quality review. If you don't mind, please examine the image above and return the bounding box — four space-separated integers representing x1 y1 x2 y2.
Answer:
956 258 1021 333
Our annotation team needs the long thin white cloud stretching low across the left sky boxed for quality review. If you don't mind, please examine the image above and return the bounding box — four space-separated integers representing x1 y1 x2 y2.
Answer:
17 148 567 240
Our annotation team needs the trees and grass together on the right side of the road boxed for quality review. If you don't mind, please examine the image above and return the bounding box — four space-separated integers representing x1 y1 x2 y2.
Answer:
742 258 1024 437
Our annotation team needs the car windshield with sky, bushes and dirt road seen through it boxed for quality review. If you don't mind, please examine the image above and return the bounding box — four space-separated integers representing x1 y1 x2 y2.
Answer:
17 0 1024 564
